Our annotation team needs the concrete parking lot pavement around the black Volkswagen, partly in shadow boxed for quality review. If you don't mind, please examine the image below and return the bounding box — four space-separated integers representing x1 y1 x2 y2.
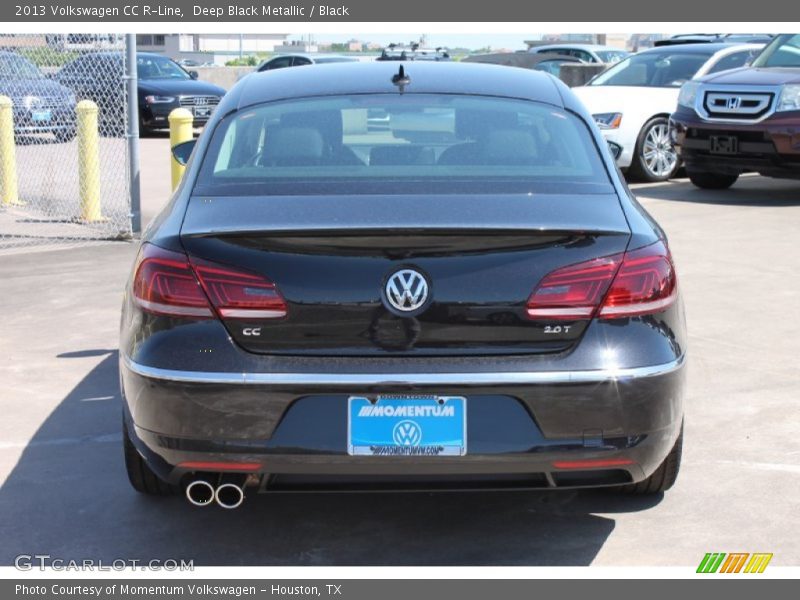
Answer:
0 137 800 569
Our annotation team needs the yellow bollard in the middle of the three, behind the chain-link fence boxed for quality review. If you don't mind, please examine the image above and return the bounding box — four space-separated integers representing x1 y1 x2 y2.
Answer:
75 100 104 223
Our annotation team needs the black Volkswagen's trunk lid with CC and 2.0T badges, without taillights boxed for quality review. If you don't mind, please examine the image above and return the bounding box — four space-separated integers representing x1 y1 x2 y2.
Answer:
181 194 630 356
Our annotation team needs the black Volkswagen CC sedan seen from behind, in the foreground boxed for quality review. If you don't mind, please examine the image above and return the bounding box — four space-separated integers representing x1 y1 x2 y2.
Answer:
120 62 686 508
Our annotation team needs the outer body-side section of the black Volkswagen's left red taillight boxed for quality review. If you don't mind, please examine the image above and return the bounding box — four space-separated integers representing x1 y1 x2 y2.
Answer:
133 244 213 318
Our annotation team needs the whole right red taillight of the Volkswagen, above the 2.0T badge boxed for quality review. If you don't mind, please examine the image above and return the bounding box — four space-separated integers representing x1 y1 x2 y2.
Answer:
526 242 677 320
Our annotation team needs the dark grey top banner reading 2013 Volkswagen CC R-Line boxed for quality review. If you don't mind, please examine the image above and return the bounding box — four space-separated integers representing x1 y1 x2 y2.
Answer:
0 0 800 22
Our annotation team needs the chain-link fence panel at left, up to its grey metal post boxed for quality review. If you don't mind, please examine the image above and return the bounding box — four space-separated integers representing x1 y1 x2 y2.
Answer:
0 34 131 251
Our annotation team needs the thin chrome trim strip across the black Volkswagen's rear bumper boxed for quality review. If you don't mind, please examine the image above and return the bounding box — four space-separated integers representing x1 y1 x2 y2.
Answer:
120 354 686 386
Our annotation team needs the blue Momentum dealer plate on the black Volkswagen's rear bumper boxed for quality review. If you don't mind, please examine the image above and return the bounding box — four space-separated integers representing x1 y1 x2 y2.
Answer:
347 396 467 457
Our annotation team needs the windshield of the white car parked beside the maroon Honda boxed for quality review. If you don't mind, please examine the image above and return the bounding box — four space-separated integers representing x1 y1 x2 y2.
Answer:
589 51 713 88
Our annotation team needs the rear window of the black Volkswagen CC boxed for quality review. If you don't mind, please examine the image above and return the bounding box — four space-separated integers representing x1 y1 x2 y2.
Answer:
195 94 610 196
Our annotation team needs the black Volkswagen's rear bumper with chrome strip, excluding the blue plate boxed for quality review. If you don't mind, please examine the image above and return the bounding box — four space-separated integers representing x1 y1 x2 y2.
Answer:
120 356 685 489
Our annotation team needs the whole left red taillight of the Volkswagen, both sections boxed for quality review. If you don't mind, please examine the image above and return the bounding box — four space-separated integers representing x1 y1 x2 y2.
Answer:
133 244 286 320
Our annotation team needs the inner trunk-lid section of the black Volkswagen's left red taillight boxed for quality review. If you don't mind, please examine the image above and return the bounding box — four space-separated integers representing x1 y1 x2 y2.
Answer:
192 259 286 320
